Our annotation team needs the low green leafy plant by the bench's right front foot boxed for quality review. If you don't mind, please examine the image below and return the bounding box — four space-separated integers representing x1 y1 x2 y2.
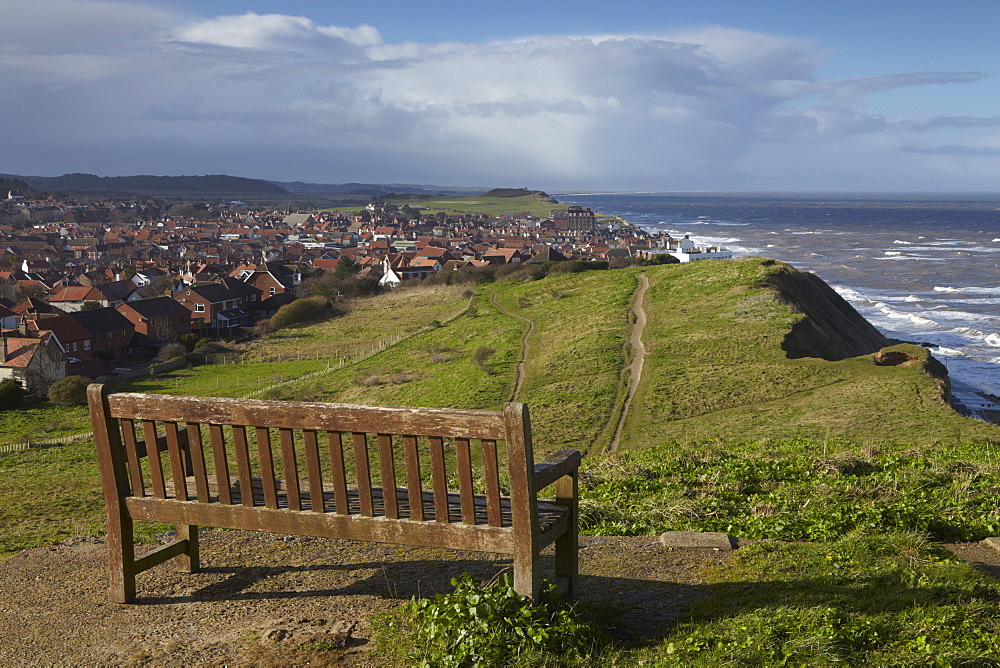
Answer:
374 573 601 666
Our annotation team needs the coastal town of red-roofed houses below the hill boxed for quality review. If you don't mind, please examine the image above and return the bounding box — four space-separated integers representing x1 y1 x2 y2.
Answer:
0 191 732 392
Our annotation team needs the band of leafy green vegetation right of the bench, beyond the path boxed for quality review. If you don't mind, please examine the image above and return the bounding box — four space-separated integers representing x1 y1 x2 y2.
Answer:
580 439 1000 541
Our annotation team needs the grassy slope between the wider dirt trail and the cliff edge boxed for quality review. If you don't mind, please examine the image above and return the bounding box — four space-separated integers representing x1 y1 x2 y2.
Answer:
622 258 1000 448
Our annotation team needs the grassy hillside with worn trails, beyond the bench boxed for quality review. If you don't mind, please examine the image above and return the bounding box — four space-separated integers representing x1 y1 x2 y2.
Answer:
246 258 1000 450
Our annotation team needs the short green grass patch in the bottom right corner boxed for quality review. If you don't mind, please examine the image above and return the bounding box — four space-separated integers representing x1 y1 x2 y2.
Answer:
644 533 1000 666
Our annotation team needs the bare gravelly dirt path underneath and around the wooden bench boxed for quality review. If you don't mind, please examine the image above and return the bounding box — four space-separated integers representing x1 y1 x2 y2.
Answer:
0 531 730 665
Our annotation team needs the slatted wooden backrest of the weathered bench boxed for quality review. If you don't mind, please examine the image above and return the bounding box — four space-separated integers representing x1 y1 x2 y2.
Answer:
88 385 537 527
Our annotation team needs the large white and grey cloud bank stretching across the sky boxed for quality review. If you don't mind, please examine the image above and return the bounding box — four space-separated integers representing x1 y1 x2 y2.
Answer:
0 0 1000 188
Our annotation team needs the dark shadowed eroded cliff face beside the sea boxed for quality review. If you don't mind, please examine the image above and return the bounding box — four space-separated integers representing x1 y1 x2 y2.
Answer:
762 260 899 361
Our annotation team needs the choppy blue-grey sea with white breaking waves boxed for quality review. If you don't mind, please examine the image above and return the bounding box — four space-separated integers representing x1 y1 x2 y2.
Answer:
557 193 1000 408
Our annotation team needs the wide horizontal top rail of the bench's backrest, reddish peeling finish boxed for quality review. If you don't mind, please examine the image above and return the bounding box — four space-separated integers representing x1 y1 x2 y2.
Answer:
108 392 504 439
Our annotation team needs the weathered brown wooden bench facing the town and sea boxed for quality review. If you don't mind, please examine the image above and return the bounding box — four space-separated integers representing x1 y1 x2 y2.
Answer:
88 384 581 603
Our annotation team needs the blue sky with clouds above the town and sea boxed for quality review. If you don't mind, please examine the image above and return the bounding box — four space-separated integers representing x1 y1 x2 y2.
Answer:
0 0 1000 192
